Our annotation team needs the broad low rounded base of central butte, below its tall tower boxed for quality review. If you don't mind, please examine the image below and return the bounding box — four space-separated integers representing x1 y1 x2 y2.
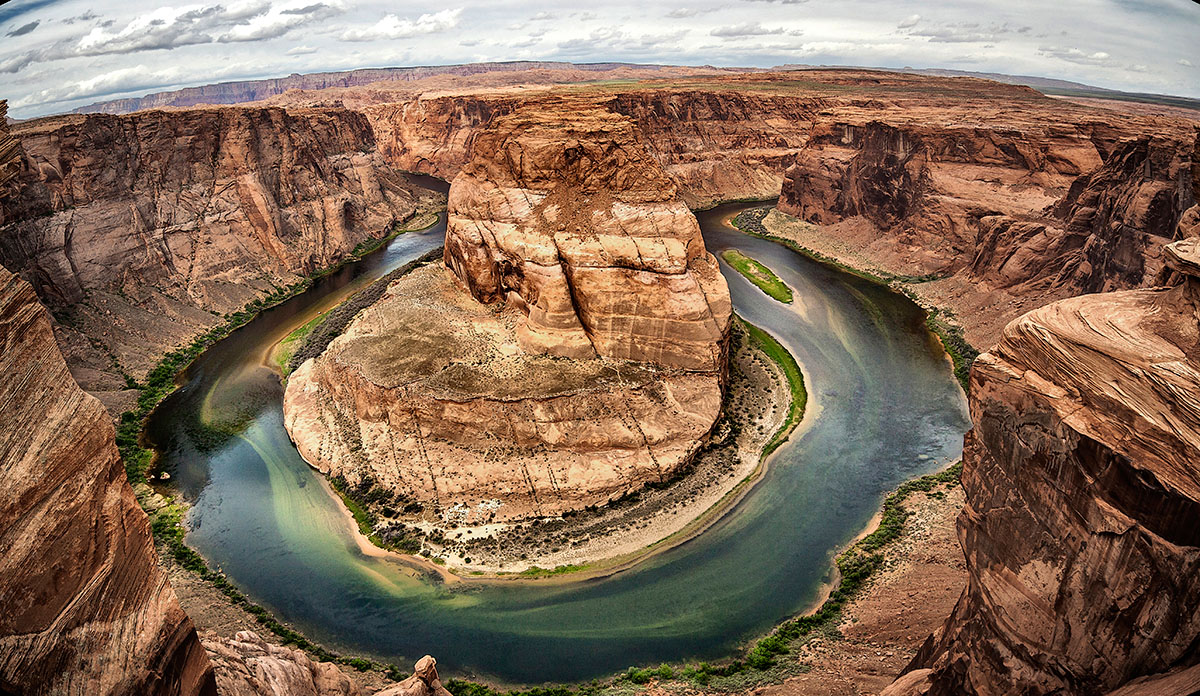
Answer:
283 266 721 526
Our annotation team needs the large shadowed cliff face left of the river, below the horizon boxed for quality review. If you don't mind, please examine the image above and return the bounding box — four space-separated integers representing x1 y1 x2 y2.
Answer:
0 108 429 408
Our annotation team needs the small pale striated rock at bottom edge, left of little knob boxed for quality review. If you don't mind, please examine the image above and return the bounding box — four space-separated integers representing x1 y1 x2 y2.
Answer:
204 631 357 696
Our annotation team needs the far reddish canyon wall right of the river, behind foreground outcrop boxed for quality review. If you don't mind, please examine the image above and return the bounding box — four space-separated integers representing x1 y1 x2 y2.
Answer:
779 113 1196 346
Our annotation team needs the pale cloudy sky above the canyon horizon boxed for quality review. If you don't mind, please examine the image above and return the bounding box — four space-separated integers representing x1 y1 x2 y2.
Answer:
0 0 1200 118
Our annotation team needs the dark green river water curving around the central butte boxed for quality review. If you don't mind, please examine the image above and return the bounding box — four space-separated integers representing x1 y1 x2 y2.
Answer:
148 198 968 683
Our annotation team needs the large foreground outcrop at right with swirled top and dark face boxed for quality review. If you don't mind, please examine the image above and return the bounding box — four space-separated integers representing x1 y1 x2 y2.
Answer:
887 239 1200 696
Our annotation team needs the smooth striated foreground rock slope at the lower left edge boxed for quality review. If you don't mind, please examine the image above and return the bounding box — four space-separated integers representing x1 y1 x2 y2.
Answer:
0 269 214 696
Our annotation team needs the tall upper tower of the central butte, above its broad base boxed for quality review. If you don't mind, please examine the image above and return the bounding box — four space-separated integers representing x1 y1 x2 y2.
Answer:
445 101 731 371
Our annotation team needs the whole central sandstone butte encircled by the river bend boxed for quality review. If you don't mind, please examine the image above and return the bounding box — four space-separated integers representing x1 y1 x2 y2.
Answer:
283 102 732 523
